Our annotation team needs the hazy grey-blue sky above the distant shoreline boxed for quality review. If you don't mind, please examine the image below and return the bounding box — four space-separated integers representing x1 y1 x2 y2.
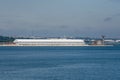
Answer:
0 0 120 38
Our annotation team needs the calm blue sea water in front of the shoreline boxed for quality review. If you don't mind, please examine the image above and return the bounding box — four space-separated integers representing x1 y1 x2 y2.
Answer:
0 47 120 80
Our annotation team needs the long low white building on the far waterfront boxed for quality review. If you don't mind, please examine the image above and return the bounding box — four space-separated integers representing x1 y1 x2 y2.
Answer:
14 39 86 46
